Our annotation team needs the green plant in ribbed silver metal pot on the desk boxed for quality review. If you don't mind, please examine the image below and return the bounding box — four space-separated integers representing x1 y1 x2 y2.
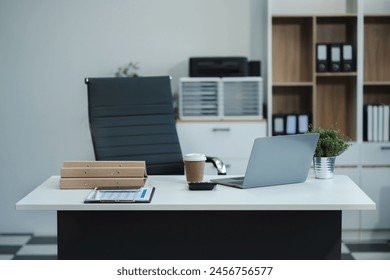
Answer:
307 126 351 179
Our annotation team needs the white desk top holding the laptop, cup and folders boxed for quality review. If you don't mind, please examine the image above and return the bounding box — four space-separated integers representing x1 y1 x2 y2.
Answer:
16 175 376 211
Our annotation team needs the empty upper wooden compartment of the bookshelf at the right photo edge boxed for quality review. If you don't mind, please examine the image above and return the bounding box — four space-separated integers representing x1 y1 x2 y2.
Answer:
364 16 390 82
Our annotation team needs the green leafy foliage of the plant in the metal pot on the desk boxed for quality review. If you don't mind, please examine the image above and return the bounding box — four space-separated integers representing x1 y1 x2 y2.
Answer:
307 126 351 157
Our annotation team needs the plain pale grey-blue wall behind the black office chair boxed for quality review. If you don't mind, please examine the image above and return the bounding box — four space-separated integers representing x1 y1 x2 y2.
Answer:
0 0 266 234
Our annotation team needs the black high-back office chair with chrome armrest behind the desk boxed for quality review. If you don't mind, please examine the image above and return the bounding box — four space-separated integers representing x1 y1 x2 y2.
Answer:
85 76 226 175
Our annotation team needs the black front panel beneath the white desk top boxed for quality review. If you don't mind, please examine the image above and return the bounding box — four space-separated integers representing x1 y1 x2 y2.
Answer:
57 211 341 260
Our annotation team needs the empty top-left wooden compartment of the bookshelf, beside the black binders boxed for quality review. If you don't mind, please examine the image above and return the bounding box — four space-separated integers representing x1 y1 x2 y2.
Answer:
272 17 313 83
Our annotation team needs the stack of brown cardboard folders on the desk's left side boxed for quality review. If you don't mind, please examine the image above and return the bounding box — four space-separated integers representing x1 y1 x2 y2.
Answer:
60 161 147 189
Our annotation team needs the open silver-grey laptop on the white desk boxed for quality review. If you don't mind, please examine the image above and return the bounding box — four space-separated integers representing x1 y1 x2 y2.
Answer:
211 133 320 189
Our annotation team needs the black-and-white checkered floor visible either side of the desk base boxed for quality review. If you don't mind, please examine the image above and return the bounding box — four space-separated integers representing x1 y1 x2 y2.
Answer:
0 234 390 260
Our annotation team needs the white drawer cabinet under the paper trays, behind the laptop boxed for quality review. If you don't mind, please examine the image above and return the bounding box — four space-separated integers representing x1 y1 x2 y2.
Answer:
176 121 267 175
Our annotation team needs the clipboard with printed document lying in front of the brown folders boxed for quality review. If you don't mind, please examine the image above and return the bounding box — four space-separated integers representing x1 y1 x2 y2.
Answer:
84 187 155 203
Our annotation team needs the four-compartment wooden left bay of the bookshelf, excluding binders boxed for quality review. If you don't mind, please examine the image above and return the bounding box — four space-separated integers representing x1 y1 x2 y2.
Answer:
270 14 357 140
